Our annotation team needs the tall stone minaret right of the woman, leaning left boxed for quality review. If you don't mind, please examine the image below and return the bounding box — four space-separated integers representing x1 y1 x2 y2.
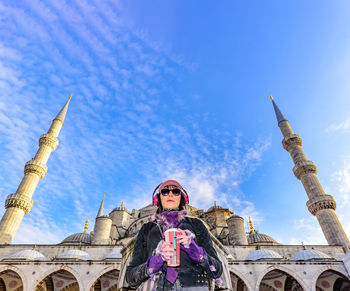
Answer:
270 96 350 252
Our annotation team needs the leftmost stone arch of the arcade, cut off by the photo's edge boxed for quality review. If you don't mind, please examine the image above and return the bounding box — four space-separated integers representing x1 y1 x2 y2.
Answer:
0 266 24 291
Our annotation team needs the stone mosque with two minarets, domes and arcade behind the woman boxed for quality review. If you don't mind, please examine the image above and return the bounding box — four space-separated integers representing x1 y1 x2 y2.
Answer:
0 97 350 291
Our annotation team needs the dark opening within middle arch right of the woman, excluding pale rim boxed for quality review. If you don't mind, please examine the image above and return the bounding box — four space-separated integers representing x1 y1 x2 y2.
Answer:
259 270 304 291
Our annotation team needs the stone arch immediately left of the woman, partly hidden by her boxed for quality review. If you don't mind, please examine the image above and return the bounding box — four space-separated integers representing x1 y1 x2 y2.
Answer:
88 265 120 291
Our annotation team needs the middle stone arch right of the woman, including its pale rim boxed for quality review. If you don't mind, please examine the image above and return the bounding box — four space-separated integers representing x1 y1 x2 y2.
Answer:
255 266 308 291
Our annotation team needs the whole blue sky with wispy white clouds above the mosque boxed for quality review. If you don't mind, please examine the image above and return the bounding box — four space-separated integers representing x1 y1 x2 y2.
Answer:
0 0 350 244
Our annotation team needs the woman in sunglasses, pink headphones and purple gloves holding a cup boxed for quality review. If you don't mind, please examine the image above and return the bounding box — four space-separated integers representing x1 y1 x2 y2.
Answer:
126 180 222 291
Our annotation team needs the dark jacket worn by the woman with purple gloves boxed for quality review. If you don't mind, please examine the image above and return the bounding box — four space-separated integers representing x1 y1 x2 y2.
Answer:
126 217 222 290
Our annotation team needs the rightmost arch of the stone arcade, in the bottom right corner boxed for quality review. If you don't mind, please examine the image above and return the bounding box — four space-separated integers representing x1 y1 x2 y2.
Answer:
316 268 350 291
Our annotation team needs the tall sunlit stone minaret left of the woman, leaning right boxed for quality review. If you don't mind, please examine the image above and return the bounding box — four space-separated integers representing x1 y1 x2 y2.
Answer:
0 95 72 244
